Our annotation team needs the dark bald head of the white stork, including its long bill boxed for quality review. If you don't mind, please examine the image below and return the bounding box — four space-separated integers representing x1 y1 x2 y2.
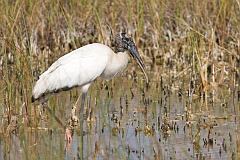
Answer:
114 32 148 83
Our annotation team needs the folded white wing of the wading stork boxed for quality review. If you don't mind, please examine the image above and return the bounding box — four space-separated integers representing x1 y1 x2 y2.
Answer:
33 44 112 99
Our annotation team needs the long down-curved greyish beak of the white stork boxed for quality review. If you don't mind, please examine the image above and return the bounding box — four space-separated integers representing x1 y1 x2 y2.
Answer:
128 44 148 83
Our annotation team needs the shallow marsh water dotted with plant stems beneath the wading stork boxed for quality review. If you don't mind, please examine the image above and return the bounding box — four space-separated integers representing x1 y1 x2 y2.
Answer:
0 74 240 160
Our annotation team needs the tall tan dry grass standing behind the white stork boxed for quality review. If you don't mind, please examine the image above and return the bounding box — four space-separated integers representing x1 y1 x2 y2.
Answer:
0 0 240 145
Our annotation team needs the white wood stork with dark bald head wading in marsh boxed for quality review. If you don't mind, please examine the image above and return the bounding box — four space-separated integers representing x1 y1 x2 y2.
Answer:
32 33 148 141
